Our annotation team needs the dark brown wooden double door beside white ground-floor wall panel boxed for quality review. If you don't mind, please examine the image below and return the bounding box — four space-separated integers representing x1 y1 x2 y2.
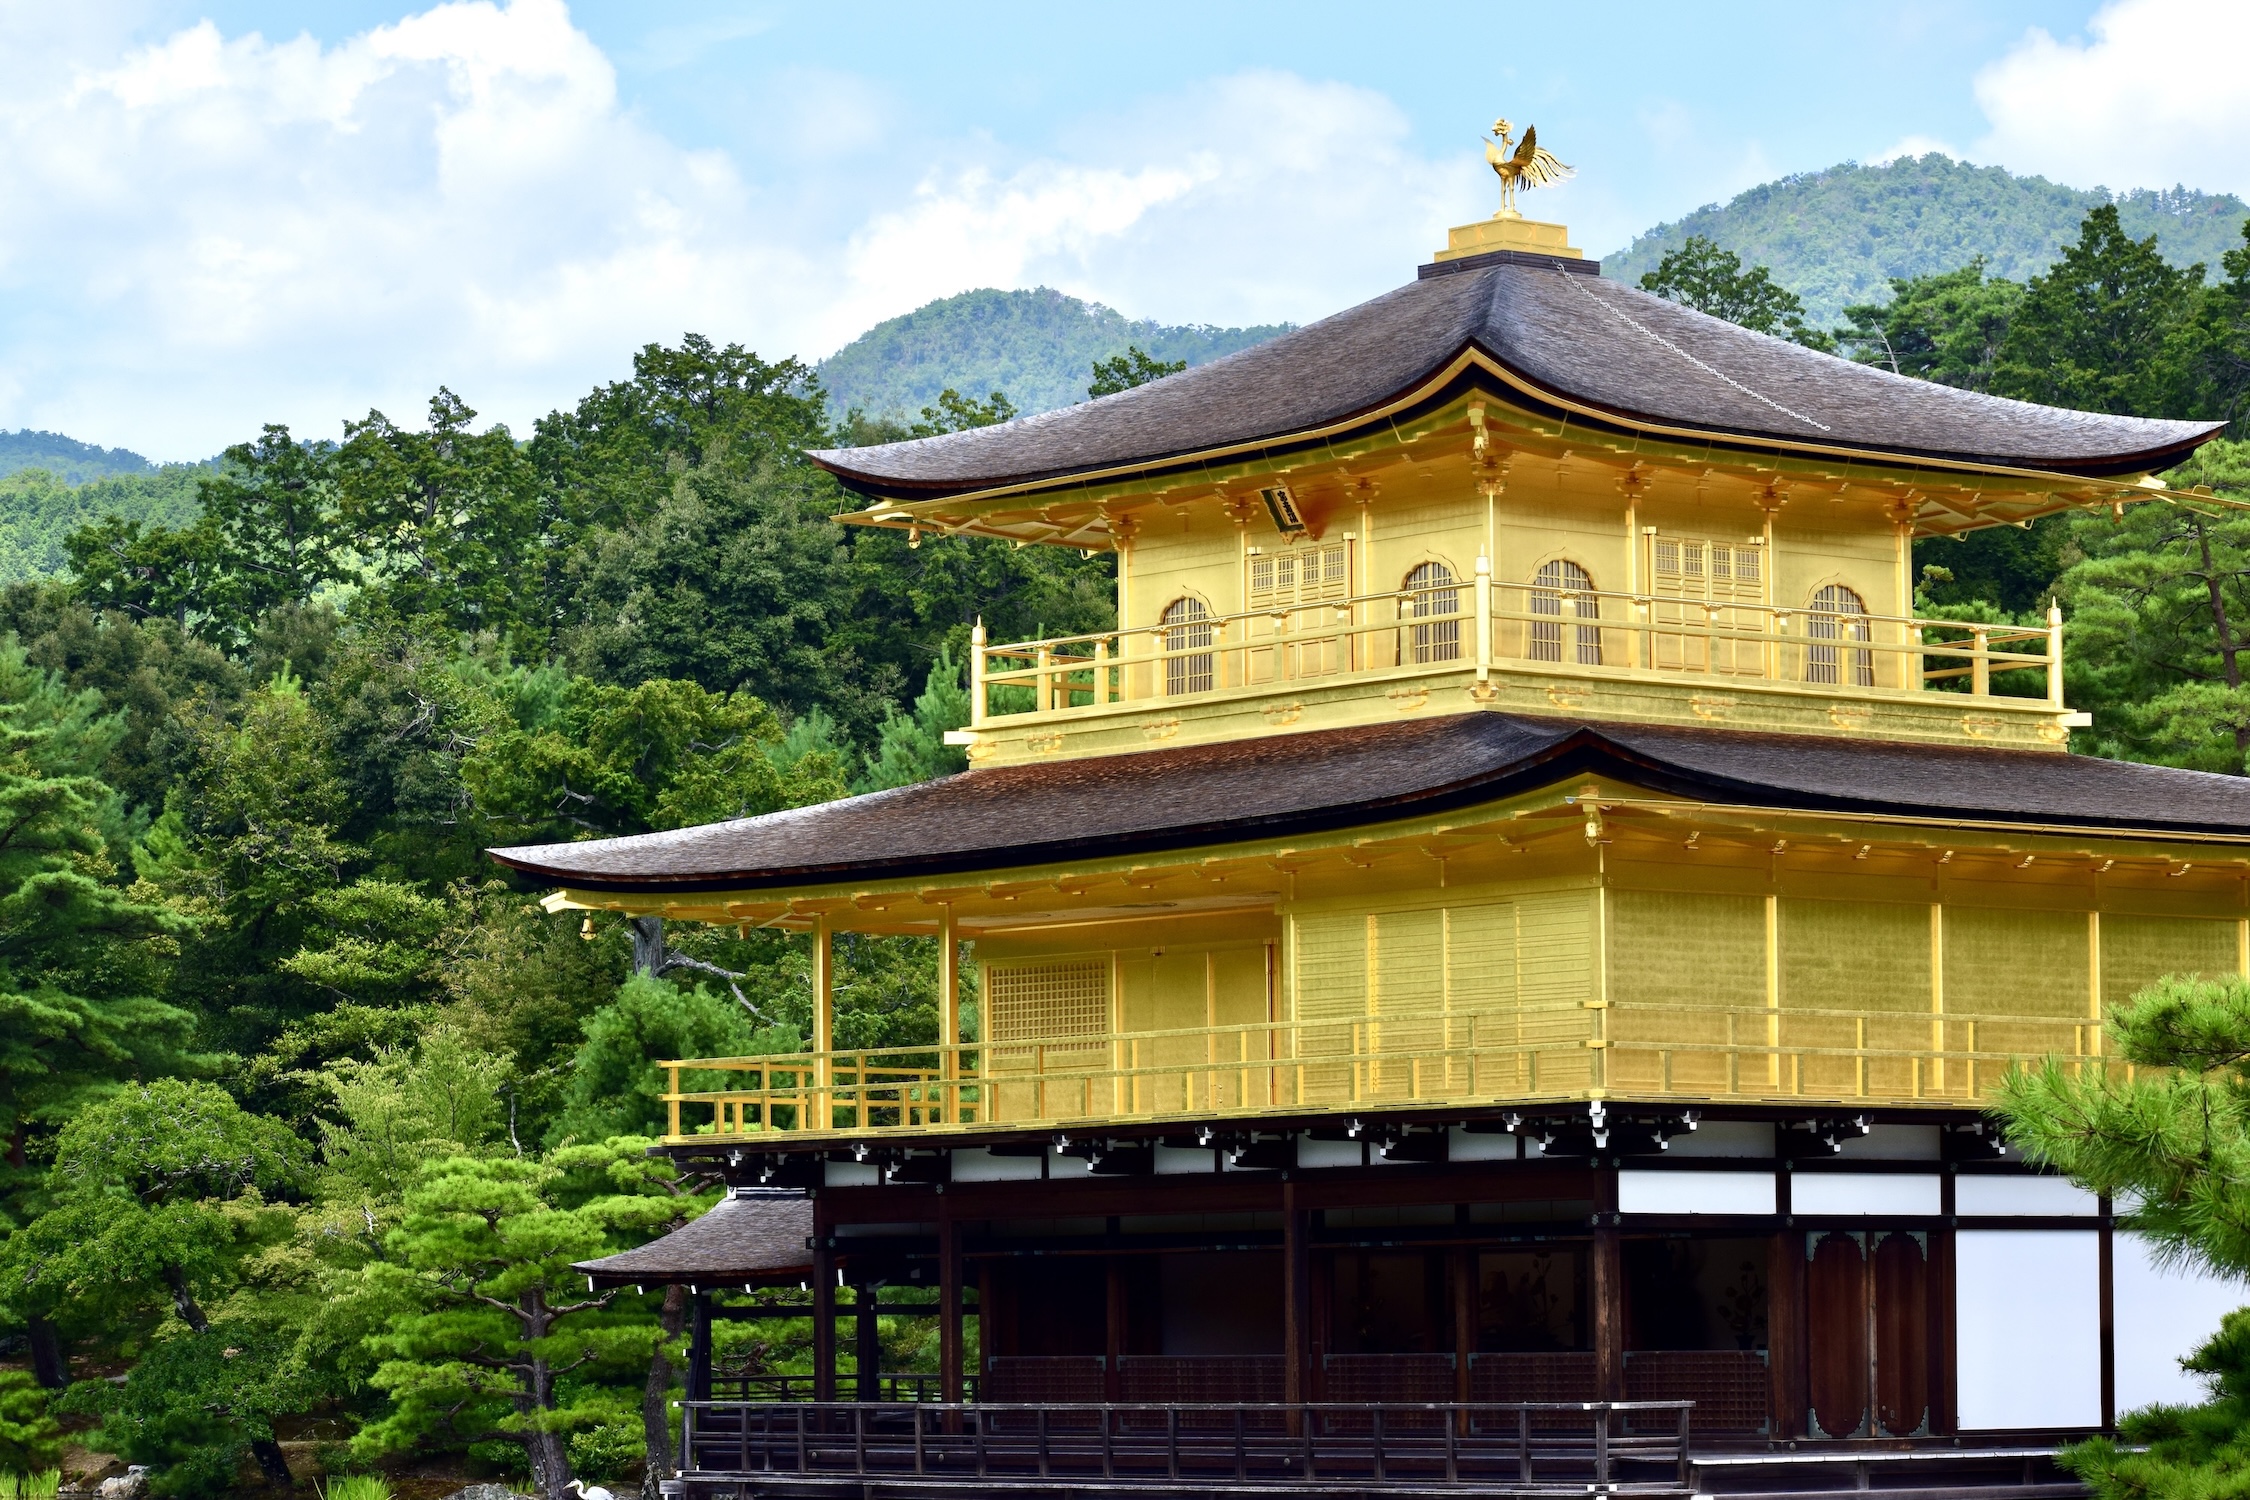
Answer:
1805 1230 1931 1437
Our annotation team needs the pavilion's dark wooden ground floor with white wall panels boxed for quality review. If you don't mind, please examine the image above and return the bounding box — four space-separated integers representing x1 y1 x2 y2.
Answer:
619 1106 2237 1493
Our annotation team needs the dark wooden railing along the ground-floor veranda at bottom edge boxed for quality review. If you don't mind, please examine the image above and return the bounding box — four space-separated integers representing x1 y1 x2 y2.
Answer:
680 1401 1694 1496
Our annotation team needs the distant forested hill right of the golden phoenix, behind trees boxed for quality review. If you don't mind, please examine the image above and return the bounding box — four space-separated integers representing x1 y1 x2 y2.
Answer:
1602 153 2250 326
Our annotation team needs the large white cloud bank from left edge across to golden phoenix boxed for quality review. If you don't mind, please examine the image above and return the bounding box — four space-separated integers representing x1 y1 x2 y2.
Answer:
0 0 1476 459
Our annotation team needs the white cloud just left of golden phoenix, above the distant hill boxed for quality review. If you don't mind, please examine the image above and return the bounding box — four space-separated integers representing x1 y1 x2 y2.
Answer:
842 72 1476 339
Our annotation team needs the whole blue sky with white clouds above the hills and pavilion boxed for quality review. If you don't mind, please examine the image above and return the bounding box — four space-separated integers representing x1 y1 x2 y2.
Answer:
0 0 2250 457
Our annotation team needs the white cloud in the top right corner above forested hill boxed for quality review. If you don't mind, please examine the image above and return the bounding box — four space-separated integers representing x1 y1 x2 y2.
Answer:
1976 0 2250 193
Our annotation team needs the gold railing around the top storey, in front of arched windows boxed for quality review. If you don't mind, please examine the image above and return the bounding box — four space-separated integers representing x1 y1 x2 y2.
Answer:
970 573 2063 726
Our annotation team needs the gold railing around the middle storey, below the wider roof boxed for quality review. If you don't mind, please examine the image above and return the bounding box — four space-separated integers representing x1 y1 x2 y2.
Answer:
659 1001 2108 1142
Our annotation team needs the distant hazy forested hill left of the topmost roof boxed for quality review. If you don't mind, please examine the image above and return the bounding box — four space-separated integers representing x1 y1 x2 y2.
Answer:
819 286 1289 416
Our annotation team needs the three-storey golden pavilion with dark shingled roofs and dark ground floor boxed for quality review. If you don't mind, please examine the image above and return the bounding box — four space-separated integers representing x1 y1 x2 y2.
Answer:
510 199 2250 1496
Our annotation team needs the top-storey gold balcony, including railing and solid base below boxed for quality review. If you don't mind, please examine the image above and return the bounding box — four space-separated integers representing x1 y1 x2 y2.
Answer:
956 571 2084 762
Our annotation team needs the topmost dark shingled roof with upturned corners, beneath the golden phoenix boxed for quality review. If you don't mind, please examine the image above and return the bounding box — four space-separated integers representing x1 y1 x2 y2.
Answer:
812 256 2221 499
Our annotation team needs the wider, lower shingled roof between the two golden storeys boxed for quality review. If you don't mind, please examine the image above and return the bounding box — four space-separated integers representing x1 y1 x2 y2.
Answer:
493 713 2250 891
